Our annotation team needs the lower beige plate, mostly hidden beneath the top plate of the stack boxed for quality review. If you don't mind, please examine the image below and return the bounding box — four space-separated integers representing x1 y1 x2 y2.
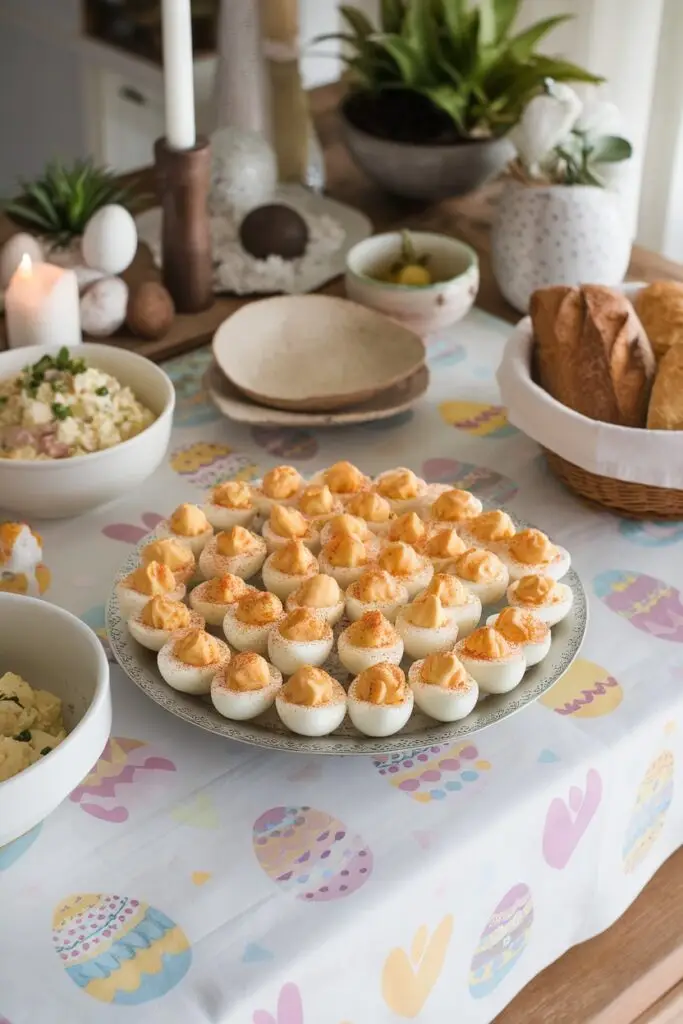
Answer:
204 364 429 427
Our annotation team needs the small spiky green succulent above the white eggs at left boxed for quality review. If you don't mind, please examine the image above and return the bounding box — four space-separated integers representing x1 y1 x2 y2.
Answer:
2 160 139 247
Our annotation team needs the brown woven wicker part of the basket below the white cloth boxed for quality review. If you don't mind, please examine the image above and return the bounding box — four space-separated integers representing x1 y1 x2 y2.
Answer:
544 449 683 520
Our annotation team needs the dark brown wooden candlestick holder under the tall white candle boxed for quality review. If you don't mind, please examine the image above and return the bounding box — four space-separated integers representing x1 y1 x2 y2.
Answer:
155 137 214 313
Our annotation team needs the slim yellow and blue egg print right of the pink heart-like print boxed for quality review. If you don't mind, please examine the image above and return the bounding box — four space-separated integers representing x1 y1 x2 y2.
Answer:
622 751 675 874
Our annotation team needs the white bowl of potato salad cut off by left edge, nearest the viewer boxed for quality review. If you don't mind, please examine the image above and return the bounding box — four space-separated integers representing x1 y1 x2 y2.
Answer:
0 593 112 847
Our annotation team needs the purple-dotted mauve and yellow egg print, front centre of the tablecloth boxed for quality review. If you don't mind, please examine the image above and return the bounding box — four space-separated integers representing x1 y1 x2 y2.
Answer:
253 807 373 902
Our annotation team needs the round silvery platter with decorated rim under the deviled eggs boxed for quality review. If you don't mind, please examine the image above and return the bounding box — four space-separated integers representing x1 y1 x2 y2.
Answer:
106 523 588 755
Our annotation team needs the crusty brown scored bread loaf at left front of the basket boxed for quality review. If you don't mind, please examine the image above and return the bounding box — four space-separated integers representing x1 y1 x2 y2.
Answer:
530 285 655 427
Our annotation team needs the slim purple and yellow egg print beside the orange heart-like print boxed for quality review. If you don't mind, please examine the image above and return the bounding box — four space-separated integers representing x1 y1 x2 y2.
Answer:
469 883 533 999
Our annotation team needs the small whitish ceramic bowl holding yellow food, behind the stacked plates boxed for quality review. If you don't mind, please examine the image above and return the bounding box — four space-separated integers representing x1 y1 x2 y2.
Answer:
346 231 479 337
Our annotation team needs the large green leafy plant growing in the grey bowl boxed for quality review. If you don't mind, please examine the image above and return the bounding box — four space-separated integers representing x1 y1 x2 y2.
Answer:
315 0 602 138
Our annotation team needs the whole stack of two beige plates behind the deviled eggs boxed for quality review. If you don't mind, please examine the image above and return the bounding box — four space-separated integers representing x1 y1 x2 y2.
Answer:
206 295 429 427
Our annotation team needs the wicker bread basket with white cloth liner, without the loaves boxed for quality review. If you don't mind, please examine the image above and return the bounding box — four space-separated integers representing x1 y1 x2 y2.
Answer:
498 285 683 520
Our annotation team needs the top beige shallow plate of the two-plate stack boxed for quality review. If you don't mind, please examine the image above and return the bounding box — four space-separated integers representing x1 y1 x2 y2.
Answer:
213 295 426 413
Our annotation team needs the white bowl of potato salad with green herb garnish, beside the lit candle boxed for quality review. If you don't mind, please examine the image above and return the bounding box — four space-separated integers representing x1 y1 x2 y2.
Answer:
0 342 175 519
